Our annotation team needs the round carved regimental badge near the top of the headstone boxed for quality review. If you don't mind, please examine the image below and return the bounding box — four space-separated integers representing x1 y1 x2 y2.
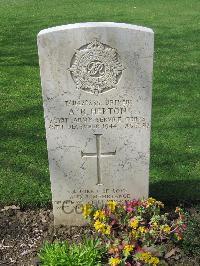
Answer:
69 40 124 95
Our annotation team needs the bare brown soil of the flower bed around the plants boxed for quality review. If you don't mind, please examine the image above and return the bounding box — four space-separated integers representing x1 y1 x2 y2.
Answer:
0 206 200 266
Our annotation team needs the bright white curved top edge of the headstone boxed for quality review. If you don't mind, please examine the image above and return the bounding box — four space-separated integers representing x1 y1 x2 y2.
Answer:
38 22 154 37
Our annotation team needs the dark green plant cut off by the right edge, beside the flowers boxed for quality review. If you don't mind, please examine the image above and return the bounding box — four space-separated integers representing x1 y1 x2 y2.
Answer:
182 208 200 257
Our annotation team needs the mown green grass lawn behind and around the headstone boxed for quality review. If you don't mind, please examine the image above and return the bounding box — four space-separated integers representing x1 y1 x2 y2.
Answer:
0 0 200 206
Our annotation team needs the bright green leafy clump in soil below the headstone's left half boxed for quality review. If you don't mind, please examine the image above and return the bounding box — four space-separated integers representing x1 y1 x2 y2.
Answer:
39 239 104 266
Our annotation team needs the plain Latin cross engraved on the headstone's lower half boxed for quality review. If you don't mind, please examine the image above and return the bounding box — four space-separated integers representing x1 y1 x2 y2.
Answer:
81 134 116 185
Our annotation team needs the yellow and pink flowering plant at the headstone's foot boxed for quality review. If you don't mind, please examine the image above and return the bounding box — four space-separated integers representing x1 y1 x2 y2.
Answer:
83 198 186 266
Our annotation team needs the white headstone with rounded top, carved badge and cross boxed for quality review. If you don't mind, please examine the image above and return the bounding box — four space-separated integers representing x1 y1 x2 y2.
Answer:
38 22 154 225
